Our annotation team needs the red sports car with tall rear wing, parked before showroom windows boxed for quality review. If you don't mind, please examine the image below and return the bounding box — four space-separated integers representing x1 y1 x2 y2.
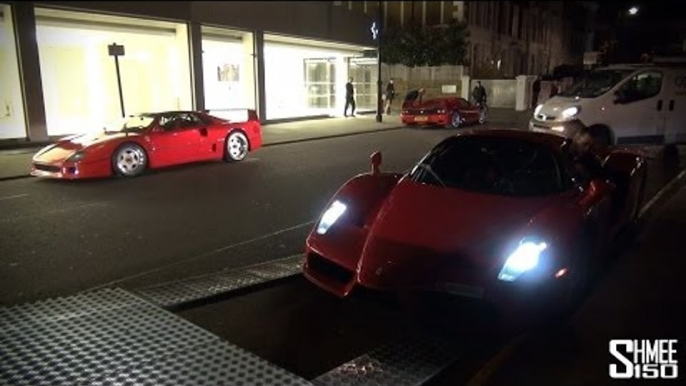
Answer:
31 110 262 179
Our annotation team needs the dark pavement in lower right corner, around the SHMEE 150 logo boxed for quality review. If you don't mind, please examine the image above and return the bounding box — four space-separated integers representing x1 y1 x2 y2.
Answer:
486 175 686 386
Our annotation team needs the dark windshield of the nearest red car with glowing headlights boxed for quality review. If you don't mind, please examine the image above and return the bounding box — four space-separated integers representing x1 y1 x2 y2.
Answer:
410 136 564 196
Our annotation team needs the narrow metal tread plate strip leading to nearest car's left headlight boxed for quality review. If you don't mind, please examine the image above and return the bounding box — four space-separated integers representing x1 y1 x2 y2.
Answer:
136 255 303 308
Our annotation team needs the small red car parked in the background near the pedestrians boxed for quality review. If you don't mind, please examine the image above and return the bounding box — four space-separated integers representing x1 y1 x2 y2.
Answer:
400 97 486 129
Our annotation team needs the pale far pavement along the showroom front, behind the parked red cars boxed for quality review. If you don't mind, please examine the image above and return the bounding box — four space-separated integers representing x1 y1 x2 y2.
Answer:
0 108 531 180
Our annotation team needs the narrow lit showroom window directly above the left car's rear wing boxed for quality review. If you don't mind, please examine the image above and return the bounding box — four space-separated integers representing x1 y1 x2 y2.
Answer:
202 26 256 117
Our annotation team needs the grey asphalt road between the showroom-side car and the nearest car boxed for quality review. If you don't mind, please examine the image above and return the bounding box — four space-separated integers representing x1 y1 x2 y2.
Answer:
0 129 462 304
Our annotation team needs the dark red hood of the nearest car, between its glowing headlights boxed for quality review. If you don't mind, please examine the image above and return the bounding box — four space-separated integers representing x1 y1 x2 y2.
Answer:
358 180 553 288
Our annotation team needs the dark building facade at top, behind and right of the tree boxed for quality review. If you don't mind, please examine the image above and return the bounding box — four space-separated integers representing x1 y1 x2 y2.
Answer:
334 1 597 78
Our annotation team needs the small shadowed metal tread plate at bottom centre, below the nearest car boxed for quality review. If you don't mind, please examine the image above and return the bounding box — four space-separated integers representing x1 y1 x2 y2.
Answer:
312 336 458 386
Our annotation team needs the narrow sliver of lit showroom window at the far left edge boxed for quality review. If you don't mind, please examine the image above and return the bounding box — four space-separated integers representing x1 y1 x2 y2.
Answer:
0 4 26 139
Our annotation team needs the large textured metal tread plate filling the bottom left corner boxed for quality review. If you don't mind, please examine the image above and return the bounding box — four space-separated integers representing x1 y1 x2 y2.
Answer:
0 289 309 386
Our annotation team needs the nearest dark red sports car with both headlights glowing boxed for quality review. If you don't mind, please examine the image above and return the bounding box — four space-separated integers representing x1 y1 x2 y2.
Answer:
304 130 645 316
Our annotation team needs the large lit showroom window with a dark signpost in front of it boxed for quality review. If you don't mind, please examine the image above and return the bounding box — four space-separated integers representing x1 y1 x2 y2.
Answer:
36 8 193 136
